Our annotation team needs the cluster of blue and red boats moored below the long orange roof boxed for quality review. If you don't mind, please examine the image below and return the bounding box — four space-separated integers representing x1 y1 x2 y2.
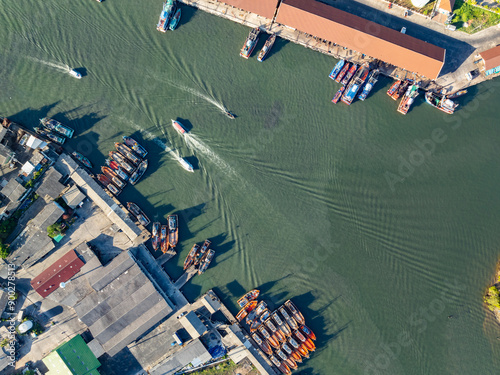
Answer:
328 60 380 105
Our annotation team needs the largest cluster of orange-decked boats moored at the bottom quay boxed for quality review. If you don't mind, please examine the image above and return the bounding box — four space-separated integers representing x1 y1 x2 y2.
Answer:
236 289 316 374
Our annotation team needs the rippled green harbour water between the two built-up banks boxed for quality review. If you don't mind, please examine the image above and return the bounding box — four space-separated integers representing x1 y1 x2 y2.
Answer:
0 0 500 375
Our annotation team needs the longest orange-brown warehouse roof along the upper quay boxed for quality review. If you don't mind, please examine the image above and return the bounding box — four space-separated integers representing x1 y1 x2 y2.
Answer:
276 0 446 79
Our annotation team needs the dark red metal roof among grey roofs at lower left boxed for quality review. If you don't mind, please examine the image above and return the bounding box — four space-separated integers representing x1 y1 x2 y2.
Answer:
31 250 85 298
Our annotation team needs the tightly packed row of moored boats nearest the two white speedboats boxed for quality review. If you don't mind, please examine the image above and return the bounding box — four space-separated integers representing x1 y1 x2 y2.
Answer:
97 136 149 197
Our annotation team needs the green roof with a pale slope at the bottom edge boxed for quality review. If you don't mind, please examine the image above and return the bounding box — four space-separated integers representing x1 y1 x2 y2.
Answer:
43 335 101 375
